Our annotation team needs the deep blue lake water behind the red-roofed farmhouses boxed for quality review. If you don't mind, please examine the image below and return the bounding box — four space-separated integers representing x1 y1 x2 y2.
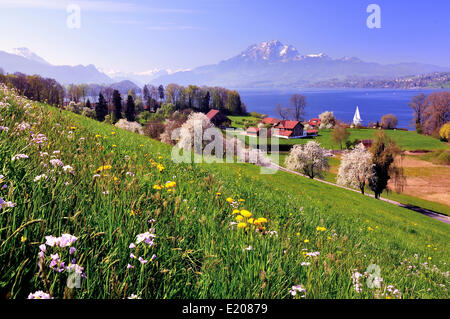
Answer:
239 89 438 130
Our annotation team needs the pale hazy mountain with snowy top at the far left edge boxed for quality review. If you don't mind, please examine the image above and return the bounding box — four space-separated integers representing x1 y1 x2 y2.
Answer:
0 48 113 84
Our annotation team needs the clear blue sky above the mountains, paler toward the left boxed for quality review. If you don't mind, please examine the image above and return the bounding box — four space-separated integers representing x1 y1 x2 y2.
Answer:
0 0 450 72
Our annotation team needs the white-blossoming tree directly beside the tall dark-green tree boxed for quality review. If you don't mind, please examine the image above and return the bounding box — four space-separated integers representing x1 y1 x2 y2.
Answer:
337 144 372 194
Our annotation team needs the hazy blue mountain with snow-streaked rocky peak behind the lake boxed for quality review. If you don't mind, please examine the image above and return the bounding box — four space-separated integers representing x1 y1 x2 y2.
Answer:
152 40 450 88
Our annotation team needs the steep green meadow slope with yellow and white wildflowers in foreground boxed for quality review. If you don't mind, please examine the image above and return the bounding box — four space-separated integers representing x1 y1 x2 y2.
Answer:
0 87 449 298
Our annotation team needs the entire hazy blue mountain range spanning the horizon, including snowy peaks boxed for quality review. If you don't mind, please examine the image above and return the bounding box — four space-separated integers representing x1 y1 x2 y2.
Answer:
0 40 450 88
